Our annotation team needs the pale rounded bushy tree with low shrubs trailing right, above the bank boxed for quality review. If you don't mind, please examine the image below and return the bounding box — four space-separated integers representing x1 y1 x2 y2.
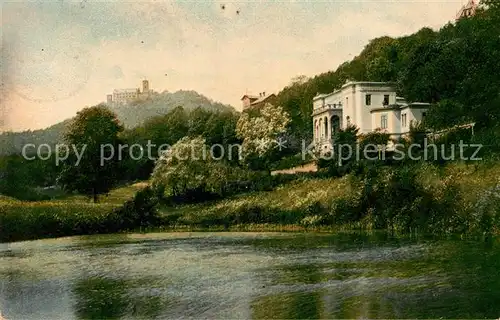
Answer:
151 137 300 203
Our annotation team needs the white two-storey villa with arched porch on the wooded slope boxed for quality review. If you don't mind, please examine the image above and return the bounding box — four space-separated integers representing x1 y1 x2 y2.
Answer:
312 81 430 152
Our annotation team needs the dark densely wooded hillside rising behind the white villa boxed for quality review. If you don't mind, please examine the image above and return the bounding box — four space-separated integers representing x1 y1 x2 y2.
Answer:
278 0 500 137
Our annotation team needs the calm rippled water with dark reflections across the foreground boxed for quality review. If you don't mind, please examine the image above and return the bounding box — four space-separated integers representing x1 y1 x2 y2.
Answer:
0 233 500 320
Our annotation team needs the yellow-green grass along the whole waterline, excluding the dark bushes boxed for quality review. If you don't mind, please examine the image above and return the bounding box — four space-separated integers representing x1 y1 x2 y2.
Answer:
0 161 500 241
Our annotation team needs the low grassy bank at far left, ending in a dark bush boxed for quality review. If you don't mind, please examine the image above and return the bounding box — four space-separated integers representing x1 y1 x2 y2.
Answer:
0 184 150 242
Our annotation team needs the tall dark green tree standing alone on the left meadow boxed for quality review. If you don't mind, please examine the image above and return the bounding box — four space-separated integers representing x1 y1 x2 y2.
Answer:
58 105 123 202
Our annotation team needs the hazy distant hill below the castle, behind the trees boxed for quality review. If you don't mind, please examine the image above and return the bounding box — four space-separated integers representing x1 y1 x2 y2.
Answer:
0 90 235 156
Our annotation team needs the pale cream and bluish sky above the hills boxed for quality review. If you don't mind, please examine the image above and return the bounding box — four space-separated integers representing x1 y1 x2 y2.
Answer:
0 0 466 131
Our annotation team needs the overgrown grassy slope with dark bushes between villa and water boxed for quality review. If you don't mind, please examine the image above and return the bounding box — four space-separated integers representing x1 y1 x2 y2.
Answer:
161 163 500 234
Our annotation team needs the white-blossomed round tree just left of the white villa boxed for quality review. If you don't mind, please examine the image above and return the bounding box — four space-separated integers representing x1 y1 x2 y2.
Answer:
236 103 291 158
